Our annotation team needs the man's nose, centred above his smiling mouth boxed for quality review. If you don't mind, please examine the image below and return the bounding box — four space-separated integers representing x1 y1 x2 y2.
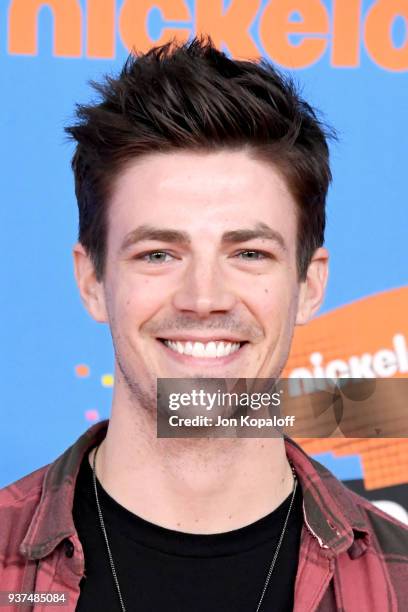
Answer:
173 258 237 318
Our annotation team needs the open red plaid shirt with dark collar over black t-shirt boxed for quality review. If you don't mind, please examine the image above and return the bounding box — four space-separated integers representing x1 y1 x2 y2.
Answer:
0 421 408 612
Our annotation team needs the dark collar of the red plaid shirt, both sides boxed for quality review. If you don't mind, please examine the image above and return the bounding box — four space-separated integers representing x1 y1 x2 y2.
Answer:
20 420 370 559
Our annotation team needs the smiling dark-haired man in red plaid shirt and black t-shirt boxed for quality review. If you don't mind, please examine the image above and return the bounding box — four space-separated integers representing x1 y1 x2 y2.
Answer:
0 39 408 612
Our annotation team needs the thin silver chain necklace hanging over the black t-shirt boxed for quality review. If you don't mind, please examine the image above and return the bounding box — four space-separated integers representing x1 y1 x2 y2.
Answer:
92 445 297 612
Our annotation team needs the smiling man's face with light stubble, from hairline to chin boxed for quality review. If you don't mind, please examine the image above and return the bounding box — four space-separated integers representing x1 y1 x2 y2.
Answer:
74 150 328 406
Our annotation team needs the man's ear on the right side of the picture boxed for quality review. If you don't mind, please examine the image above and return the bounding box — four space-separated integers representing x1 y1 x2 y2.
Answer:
296 247 329 325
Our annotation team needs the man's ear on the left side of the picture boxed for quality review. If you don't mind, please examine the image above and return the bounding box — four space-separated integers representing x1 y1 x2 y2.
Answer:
72 242 108 323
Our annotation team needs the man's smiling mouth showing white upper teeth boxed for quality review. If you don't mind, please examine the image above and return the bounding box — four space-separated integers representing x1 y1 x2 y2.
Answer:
158 338 248 363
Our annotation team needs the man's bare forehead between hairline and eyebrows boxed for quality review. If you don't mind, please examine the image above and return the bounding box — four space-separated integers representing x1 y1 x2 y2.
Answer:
109 150 296 242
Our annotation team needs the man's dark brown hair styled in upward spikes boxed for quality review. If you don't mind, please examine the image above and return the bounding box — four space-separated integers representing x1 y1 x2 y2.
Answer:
65 37 334 280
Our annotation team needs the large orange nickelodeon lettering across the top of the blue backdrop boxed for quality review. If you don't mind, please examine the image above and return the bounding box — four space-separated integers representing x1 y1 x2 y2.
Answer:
8 0 408 71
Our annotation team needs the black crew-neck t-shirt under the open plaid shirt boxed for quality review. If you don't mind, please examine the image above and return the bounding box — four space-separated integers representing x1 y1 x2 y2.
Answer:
73 456 303 612
